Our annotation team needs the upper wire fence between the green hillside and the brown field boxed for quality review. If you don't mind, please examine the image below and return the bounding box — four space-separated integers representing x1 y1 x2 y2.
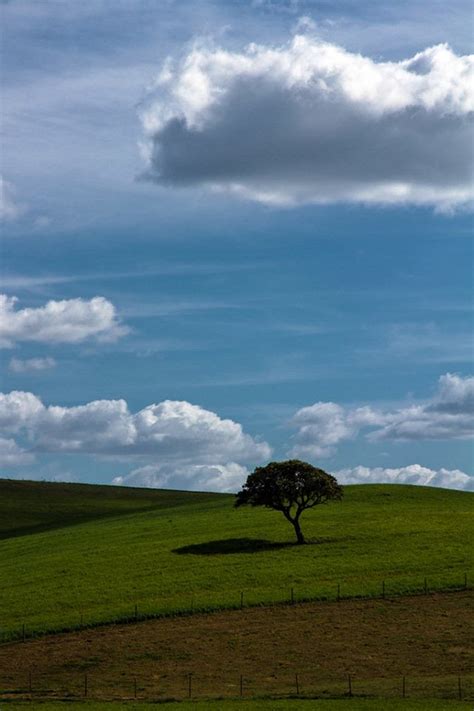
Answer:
0 573 473 644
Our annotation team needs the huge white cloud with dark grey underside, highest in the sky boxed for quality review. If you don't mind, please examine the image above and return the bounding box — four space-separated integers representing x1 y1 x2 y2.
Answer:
141 34 474 210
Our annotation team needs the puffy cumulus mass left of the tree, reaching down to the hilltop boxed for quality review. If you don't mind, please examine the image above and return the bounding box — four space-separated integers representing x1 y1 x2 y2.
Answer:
0 391 271 491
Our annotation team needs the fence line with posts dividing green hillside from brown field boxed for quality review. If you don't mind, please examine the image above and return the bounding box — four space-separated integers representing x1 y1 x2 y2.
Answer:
0 573 474 645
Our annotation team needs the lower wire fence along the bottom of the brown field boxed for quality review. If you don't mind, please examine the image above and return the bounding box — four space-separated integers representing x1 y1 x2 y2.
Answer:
0 669 474 701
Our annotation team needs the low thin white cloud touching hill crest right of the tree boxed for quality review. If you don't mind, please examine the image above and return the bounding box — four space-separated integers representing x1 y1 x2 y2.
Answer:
334 464 474 491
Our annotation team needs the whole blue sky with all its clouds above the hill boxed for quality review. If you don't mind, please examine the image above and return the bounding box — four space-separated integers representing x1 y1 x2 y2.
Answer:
0 0 474 491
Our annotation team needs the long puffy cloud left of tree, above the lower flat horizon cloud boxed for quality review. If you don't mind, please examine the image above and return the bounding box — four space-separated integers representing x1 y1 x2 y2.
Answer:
0 391 271 466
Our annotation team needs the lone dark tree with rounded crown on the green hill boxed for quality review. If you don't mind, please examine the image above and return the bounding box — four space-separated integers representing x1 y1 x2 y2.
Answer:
234 459 342 543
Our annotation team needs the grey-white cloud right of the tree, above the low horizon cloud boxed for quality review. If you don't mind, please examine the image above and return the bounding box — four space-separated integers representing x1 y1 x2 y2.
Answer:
291 373 474 457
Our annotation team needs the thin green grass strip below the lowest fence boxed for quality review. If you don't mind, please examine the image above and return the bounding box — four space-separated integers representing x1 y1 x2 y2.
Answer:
5 699 472 711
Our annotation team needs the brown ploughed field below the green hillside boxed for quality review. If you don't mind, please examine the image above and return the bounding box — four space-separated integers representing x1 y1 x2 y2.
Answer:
0 592 474 700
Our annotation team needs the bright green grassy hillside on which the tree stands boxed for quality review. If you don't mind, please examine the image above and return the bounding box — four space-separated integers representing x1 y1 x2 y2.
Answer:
0 481 474 638
